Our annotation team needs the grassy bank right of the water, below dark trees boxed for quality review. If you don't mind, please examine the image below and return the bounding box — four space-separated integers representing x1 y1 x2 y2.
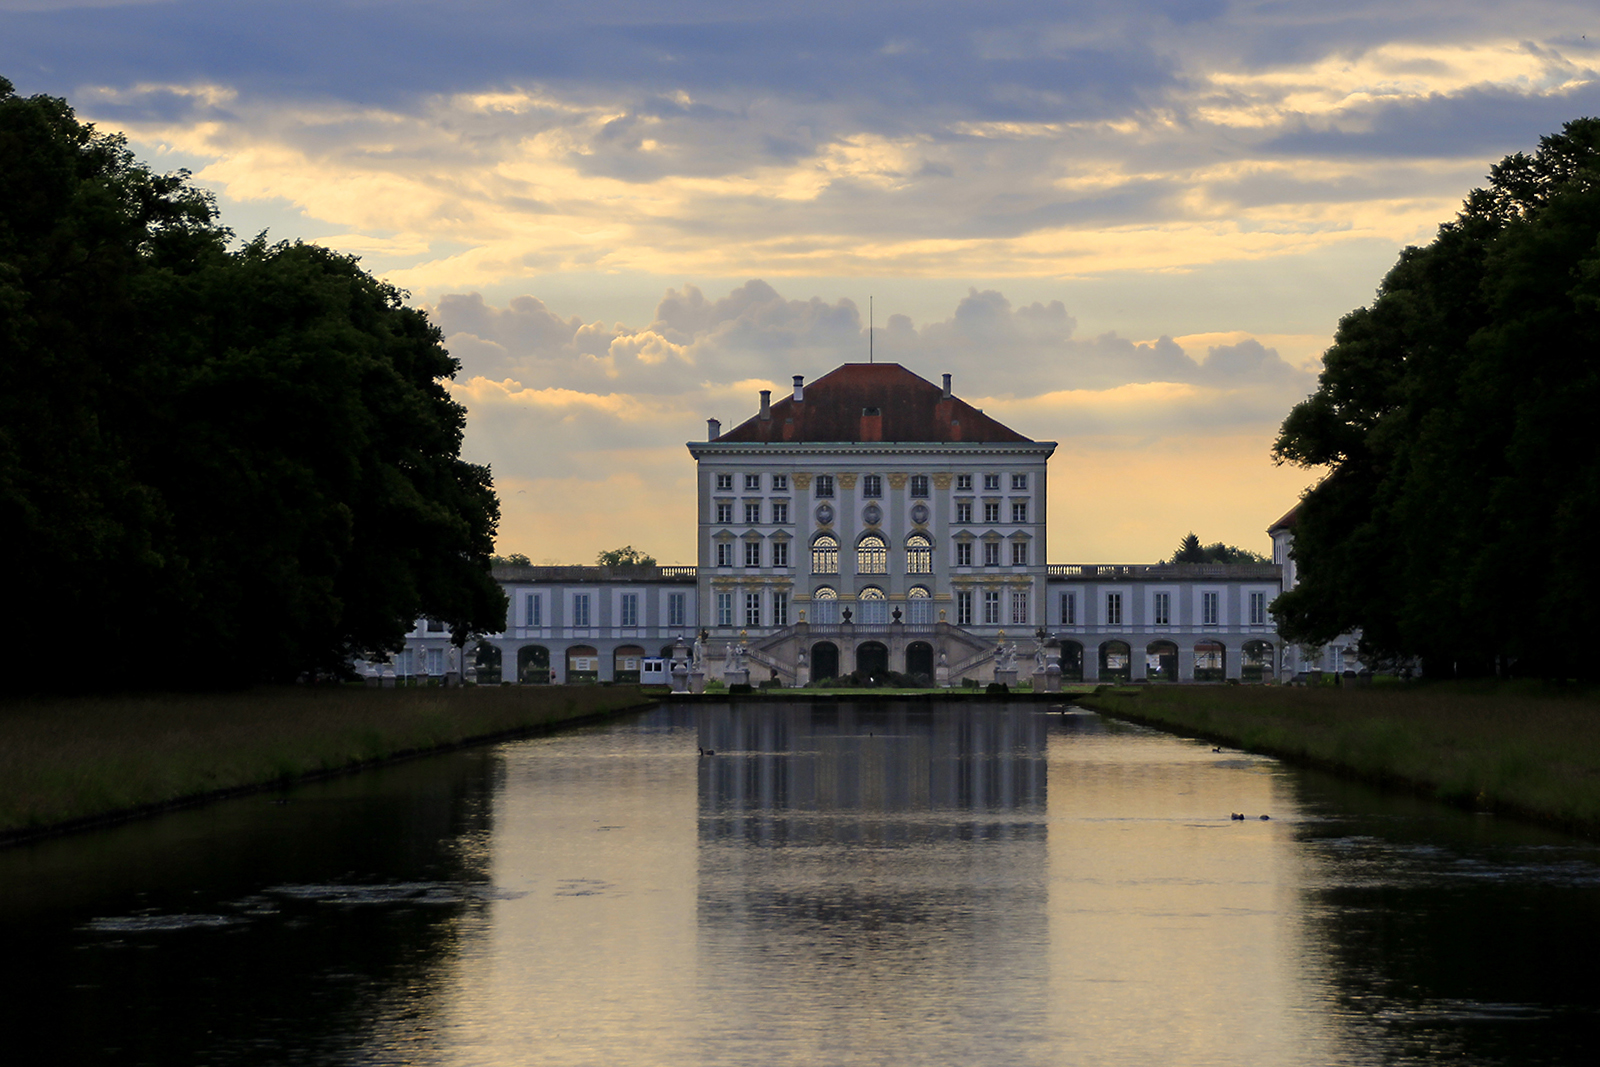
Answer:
1077 683 1600 835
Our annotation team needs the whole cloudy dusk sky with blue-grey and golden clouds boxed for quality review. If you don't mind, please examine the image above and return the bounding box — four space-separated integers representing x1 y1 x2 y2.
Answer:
0 0 1600 563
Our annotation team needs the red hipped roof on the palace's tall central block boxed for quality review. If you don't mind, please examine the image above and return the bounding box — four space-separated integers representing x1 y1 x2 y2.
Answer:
717 363 1032 443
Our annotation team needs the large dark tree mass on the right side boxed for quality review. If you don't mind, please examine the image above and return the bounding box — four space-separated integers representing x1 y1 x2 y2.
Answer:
1274 118 1600 677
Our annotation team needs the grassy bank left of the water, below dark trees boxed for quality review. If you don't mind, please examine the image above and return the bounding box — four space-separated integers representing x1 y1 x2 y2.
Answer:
0 686 645 841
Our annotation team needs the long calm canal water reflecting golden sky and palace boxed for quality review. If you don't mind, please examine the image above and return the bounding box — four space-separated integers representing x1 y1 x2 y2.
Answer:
0 704 1600 1067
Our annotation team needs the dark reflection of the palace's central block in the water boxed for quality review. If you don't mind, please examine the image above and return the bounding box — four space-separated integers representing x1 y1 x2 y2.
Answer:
698 704 1048 1062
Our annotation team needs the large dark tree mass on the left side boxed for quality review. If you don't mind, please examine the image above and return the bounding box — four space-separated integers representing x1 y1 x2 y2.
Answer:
0 78 504 688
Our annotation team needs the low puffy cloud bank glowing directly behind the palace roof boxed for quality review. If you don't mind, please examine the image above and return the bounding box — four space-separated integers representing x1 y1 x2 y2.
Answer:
432 282 1314 561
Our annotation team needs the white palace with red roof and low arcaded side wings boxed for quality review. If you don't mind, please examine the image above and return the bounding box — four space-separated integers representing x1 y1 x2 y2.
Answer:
384 363 1299 685
